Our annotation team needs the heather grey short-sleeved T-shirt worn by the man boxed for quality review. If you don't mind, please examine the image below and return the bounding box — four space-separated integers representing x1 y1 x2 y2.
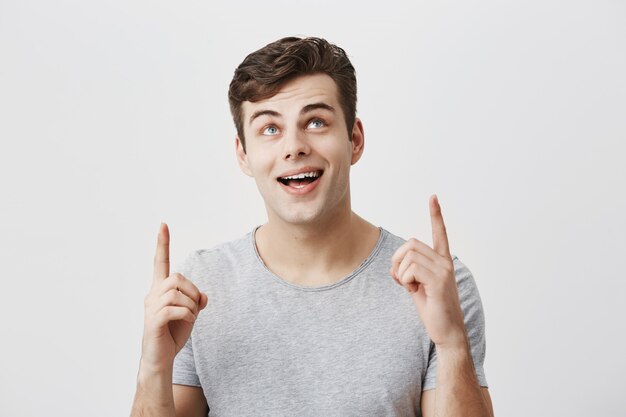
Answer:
173 226 487 417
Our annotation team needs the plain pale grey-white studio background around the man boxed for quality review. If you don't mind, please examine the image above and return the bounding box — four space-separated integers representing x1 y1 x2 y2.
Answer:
0 0 626 417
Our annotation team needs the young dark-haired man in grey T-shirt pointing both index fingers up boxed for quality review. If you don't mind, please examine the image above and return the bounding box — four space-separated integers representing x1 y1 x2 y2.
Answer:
132 38 493 417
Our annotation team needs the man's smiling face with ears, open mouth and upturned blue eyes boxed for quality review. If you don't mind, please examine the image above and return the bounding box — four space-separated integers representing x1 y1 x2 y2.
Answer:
236 74 363 224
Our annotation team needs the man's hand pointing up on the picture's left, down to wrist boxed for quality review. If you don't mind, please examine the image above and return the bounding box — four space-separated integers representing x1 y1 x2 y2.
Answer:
141 223 208 371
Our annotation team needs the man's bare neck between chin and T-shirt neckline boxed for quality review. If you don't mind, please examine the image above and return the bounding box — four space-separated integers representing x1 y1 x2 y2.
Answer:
255 210 380 286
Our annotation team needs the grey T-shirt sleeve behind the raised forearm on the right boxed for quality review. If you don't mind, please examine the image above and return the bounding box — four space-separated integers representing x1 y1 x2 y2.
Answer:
422 255 488 391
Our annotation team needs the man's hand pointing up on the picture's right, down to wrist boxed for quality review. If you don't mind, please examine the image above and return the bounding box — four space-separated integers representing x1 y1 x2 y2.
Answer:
389 195 467 347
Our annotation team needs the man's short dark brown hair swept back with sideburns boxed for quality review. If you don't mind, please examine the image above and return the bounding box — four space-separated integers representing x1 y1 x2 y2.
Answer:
228 37 356 152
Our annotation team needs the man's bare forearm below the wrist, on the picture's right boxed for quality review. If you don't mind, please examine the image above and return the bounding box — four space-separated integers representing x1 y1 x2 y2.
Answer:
435 345 492 417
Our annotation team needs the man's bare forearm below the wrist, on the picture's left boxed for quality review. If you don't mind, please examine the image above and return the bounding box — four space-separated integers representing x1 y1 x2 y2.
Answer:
130 365 176 417
